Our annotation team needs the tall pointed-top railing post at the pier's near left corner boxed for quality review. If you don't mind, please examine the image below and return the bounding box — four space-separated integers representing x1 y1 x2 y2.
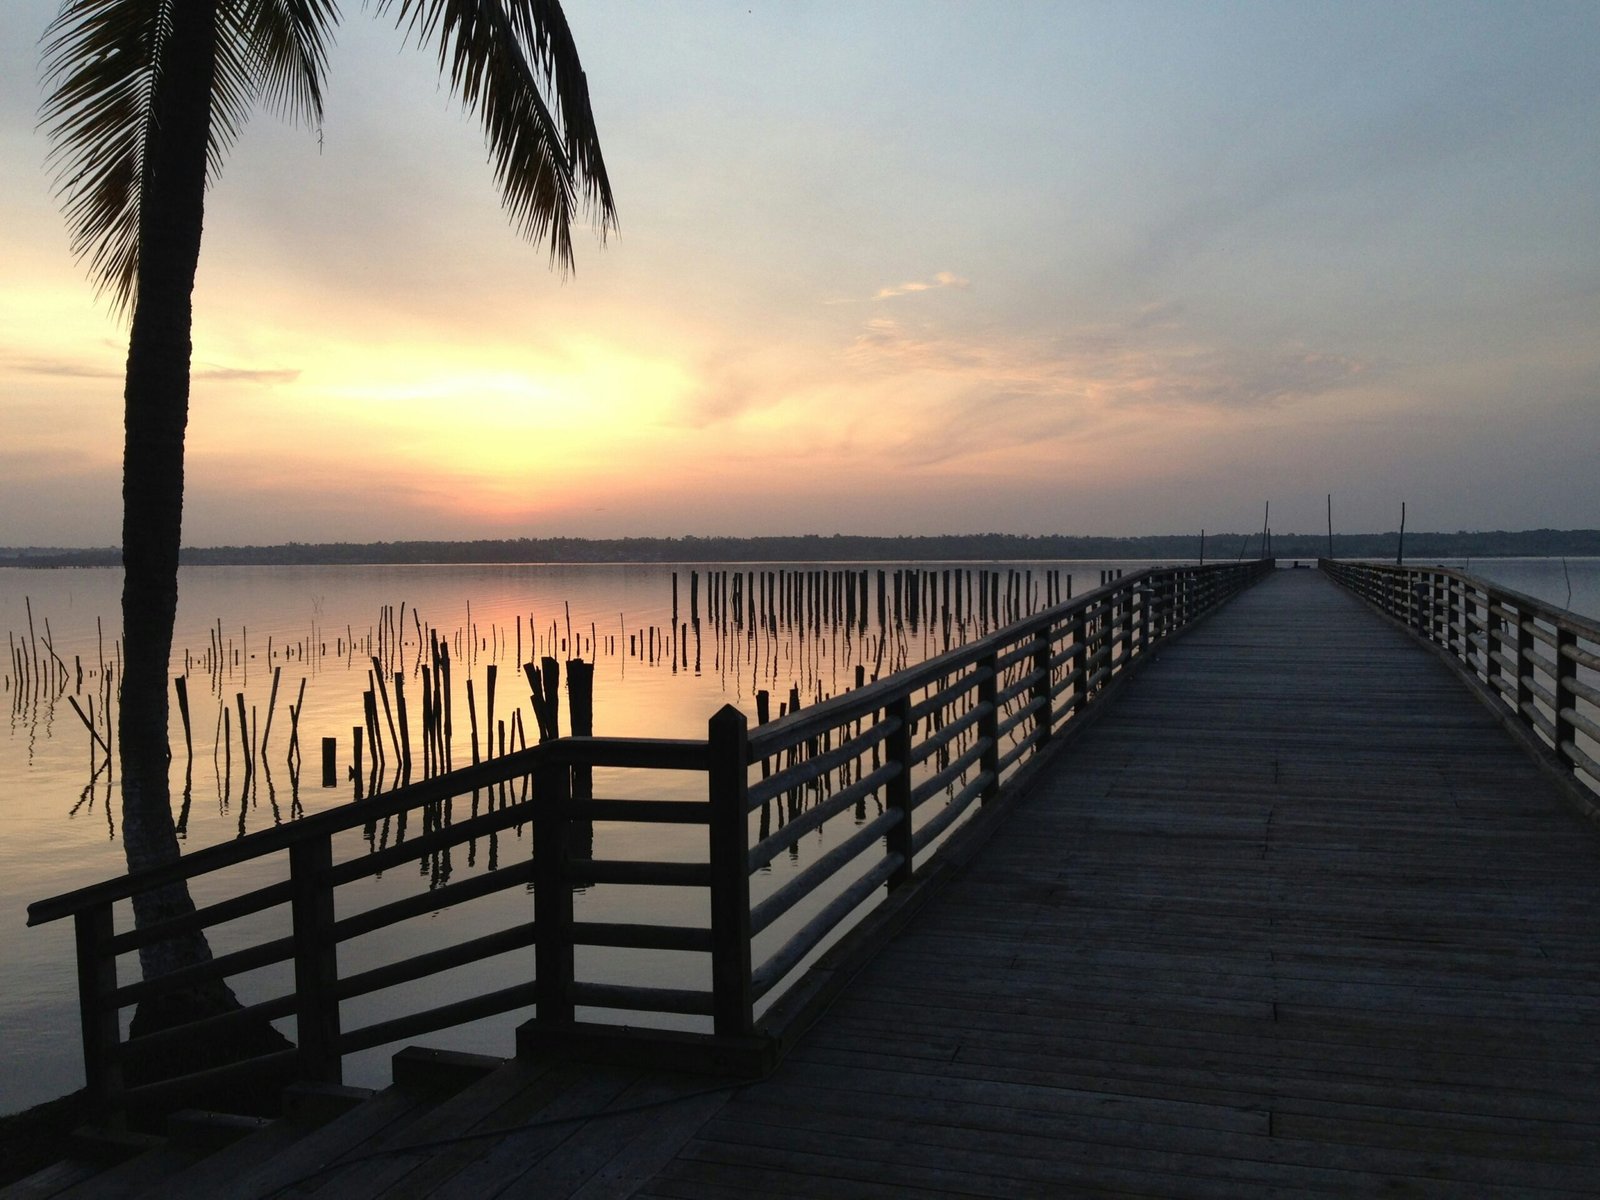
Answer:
707 704 755 1037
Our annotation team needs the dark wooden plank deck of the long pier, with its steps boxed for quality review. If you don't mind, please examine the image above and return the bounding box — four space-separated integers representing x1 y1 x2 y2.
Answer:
8 570 1600 1200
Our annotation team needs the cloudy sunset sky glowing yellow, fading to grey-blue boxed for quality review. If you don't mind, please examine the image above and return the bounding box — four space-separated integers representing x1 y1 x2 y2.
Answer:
0 0 1600 546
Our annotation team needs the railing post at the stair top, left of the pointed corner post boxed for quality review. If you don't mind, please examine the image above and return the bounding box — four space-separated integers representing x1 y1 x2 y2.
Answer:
533 755 574 1026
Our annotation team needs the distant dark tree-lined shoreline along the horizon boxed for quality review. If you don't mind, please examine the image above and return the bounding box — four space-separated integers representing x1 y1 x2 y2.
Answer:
0 530 1600 568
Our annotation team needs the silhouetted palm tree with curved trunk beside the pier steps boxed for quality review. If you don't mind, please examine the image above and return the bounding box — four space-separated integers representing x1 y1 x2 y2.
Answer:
43 0 616 1022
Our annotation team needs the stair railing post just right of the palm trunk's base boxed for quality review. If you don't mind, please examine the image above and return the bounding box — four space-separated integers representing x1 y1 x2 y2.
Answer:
290 834 342 1083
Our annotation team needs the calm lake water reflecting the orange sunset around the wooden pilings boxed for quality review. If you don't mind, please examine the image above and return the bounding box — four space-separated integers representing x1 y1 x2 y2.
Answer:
0 558 1600 1112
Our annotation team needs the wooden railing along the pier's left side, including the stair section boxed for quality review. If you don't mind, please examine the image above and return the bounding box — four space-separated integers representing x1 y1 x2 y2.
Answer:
29 560 1272 1117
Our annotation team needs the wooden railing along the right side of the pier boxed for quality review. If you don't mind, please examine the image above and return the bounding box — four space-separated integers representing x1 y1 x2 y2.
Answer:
1320 558 1600 803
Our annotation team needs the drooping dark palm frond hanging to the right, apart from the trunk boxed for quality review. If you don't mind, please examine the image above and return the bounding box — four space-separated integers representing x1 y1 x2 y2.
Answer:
378 0 616 270
